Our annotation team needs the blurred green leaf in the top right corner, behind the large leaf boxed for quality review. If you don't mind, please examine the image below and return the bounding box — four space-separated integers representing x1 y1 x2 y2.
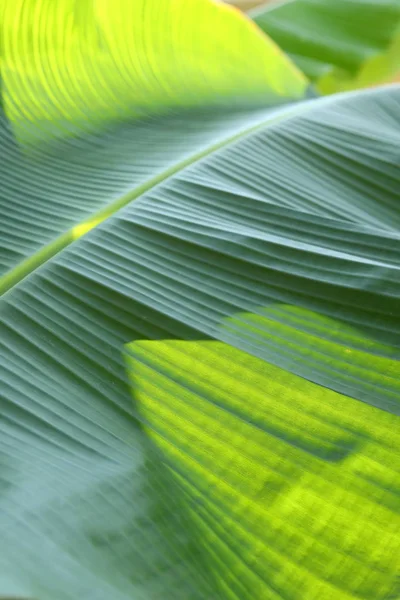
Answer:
251 0 400 94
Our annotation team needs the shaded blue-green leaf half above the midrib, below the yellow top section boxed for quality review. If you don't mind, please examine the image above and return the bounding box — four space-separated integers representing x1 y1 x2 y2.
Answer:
0 102 294 278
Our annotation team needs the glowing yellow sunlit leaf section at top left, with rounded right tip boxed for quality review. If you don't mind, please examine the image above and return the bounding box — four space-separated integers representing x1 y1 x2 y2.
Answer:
0 0 307 140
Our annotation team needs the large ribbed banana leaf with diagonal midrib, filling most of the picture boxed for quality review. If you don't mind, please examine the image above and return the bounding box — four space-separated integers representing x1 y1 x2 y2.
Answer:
0 0 400 600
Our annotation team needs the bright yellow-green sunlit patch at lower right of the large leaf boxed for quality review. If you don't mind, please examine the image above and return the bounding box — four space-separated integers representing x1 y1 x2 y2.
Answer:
127 341 400 600
